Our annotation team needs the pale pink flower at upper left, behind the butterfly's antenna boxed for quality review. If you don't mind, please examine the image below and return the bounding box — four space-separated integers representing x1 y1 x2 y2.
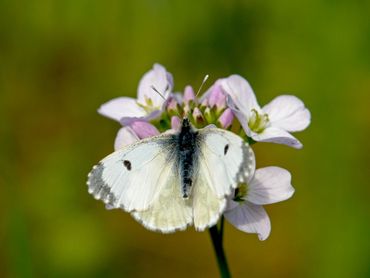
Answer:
98 64 173 121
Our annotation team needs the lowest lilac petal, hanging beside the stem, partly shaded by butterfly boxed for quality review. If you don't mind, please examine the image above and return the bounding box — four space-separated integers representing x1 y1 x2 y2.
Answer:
224 201 271 240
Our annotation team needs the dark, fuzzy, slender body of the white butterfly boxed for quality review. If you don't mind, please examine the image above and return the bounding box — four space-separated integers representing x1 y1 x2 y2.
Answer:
176 118 199 198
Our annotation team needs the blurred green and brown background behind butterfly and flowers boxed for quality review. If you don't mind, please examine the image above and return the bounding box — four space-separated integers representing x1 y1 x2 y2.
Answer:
0 0 370 277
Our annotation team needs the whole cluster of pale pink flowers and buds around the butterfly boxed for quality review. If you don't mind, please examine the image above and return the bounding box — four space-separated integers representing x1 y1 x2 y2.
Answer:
98 64 310 240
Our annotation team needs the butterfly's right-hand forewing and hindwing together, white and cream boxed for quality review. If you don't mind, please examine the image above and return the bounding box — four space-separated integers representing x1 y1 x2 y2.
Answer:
192 128 255 231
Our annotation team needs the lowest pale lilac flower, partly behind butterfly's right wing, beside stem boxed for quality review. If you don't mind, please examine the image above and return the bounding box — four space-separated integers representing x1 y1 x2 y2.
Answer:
224 167 294 240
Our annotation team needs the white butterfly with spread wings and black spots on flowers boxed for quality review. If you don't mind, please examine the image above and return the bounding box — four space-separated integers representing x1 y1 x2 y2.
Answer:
87 118 255 233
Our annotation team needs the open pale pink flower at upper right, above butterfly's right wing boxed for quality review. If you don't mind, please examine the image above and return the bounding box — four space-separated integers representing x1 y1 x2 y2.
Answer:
221 75 311 149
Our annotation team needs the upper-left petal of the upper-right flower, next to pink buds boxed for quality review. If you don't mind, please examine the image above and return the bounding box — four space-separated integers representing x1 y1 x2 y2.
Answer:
221 75 261 114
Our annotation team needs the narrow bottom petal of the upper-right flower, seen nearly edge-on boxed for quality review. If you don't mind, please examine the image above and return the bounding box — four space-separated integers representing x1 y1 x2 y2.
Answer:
251 127 303 149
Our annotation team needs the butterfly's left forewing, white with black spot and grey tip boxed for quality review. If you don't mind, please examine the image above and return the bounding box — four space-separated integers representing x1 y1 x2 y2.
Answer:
87 134 177 212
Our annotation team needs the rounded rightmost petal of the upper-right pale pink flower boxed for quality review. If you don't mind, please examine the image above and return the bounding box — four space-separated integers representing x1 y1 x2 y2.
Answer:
262 95 311 132
